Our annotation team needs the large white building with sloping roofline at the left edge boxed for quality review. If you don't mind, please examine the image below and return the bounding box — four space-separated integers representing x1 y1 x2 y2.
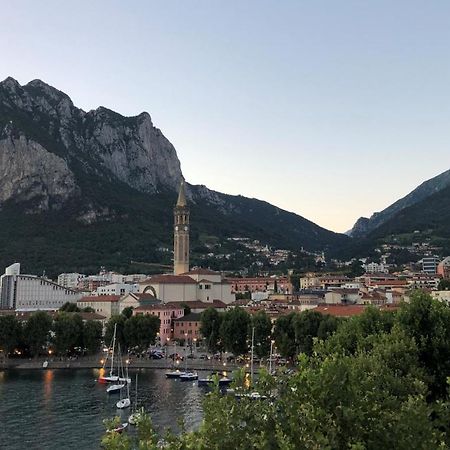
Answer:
0 263 81 311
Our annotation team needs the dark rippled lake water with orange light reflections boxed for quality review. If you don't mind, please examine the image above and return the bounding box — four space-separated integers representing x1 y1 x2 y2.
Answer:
0 369 204 450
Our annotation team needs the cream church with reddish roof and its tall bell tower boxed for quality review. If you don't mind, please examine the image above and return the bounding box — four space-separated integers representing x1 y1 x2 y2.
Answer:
139 180 235 306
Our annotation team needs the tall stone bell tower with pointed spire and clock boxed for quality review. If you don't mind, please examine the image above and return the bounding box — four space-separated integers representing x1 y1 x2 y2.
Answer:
173 180 189 275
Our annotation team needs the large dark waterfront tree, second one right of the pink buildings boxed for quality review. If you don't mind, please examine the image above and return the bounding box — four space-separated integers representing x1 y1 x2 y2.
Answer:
220 308 250 356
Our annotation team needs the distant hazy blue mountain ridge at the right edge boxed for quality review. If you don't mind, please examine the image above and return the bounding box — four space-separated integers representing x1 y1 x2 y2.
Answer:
348 170 450 237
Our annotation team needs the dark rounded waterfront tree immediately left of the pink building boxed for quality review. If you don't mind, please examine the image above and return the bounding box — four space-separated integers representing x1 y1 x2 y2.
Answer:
123 314 160 350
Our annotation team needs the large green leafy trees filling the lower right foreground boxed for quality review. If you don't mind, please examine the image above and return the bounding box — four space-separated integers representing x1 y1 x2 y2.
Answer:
102 292 450 450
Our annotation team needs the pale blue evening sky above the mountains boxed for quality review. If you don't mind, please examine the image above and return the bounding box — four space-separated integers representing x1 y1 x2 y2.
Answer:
0 0 450 232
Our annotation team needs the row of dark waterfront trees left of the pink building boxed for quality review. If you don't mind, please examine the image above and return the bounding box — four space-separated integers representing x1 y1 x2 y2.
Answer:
0 304 160 356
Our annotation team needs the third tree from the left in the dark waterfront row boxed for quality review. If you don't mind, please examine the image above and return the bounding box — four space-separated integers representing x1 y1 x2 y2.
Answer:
53 312 83 355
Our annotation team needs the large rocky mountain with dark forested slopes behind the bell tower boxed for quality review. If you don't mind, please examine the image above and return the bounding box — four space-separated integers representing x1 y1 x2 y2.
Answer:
0 78 348 274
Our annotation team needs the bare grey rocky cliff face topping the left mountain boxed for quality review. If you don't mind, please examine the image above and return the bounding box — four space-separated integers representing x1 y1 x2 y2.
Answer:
0 78 182 213
